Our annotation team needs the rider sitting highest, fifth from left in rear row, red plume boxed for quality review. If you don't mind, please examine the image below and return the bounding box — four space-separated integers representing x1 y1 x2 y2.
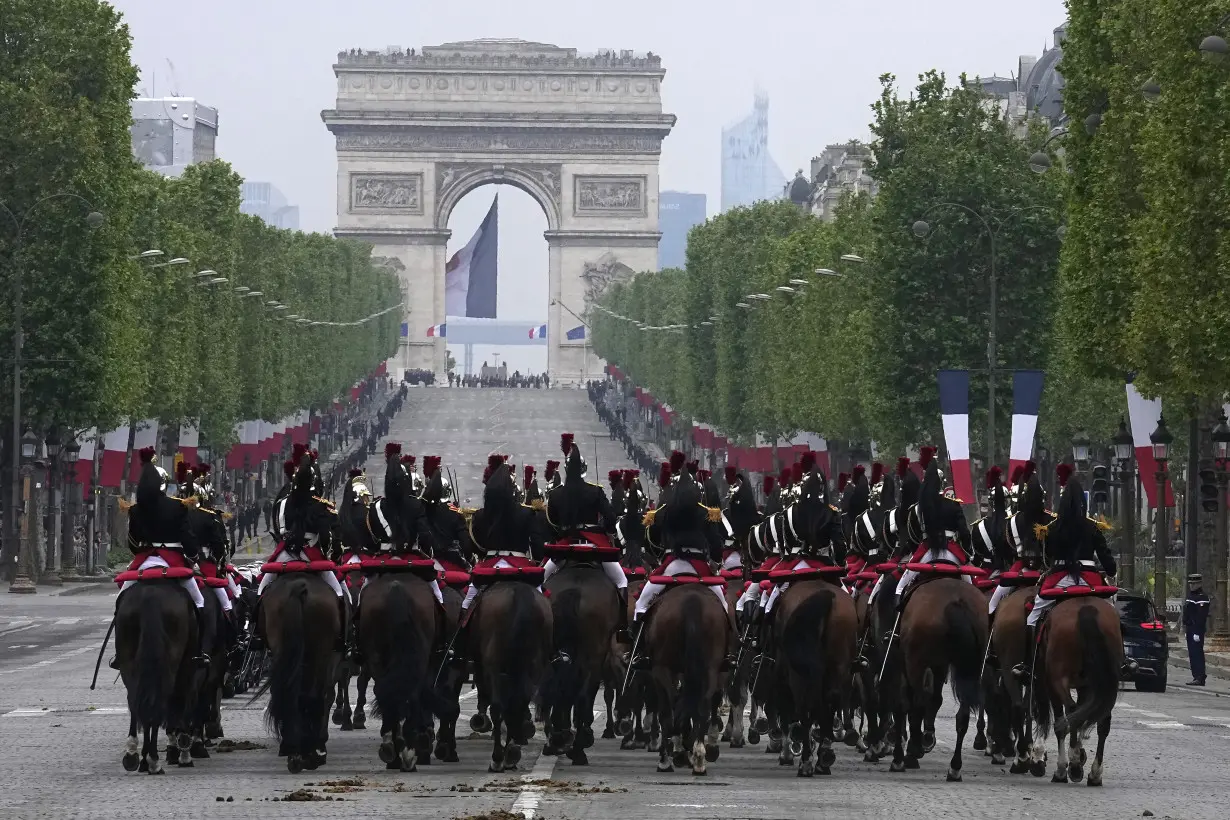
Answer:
542 433 627 639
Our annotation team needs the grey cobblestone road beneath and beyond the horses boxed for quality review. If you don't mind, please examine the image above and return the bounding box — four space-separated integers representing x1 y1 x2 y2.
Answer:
0 388 1230 820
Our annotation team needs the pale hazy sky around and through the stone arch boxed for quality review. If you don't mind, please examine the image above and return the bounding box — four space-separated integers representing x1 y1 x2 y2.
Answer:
116 0 1065 369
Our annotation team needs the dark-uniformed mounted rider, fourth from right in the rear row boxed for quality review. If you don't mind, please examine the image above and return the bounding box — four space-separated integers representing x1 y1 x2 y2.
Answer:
632 462 733 669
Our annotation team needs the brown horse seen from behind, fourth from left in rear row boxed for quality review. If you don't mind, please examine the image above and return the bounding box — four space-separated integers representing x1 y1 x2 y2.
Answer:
467 581 552 772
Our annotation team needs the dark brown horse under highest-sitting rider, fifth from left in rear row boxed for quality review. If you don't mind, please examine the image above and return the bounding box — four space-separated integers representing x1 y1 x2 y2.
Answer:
542 563 620 766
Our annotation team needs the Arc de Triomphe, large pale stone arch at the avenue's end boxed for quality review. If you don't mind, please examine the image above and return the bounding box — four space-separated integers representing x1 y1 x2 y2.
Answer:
321 39 675 382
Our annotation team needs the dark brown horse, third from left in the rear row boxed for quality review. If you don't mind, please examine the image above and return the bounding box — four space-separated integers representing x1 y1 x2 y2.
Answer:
359 573 443 772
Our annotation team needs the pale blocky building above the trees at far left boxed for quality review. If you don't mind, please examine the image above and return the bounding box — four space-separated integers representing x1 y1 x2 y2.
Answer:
132 97 218 177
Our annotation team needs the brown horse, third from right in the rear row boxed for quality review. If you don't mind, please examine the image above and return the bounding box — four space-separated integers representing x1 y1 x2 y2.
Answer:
774 579 857 777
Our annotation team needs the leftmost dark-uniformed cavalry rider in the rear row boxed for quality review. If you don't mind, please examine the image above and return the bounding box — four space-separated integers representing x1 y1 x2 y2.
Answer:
109 447 209 669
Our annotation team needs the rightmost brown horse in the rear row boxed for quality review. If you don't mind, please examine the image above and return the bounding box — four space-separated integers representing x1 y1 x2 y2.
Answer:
1033 596 1123 786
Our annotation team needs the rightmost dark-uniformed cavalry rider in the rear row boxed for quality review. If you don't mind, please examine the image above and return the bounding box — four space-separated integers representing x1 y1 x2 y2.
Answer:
1012 463 1134 679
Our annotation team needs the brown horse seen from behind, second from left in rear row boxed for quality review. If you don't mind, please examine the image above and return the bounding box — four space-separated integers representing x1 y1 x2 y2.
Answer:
258 573 342 775
